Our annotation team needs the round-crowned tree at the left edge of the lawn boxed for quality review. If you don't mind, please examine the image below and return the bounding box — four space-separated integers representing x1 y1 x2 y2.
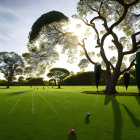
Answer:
0 52 24 88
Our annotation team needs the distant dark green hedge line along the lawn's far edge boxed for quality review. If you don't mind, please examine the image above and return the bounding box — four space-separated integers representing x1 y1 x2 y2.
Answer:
0 68 136 86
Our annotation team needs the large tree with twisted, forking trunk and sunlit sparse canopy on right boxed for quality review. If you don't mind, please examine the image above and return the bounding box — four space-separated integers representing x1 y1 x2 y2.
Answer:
74 0 140 93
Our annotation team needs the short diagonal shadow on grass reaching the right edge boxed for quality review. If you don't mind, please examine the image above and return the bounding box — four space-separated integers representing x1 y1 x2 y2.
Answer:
122 104 140 127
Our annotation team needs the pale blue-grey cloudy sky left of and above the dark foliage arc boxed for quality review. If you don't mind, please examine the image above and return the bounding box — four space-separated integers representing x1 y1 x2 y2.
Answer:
0 0 78 54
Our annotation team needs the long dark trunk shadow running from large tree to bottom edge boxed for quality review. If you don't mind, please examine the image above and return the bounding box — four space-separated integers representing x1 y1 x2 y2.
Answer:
104 95 122 140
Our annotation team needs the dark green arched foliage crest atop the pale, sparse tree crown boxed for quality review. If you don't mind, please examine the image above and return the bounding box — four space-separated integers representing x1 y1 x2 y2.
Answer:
29 11 68 41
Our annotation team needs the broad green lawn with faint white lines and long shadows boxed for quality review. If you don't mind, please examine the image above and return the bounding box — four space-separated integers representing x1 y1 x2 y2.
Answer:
0 86 140 140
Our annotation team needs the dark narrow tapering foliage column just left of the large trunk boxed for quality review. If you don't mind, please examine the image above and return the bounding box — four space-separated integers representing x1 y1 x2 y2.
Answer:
94 64 101 89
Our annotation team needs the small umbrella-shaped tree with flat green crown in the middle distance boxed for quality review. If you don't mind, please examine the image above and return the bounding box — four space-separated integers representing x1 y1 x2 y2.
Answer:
49 68 70 88
